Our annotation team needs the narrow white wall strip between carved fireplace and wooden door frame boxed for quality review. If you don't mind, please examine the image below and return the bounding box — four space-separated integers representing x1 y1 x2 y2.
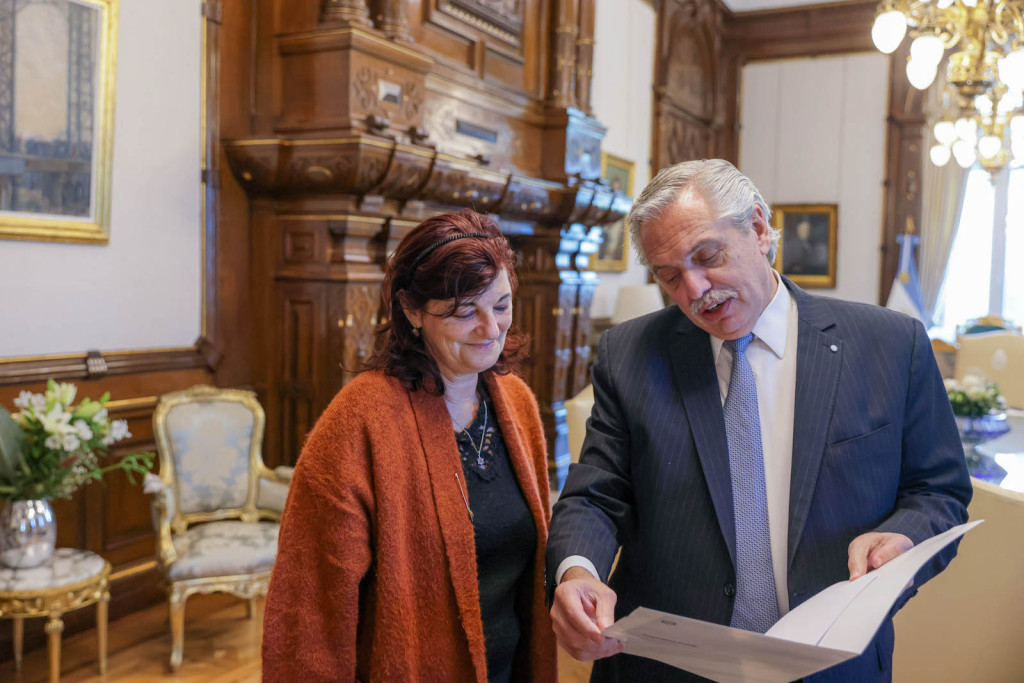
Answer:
591 0 655 317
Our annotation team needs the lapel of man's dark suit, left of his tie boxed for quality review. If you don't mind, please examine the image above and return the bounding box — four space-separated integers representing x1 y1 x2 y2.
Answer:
668 313 736 566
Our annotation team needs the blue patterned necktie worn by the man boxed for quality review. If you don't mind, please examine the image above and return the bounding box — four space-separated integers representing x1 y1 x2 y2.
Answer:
724 334 778 633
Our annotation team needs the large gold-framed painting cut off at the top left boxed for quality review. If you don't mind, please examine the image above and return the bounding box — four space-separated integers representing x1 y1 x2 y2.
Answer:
0 0 118 244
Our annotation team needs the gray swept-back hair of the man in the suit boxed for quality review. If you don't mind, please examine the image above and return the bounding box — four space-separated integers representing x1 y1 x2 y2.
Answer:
626 159 780 265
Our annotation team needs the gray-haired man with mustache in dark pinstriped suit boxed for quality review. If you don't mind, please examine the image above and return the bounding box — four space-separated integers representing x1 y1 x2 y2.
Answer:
548 160 971 682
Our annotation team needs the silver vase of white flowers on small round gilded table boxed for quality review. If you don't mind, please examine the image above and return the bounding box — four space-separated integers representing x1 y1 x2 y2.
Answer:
0 380 153 568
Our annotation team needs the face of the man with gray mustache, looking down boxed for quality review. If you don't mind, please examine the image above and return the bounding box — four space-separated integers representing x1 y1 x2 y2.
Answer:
642 190 777 339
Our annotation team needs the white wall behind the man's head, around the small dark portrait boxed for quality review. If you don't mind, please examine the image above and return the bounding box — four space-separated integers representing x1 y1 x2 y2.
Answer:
739 52 889 303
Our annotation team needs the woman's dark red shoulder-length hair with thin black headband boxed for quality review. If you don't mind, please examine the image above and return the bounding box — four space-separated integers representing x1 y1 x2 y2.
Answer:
366 209 527 394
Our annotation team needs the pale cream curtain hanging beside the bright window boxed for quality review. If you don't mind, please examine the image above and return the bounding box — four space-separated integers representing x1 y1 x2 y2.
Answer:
918 74 968 327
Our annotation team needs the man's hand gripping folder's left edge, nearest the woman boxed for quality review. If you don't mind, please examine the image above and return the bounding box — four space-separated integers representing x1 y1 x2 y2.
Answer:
551 567 623 661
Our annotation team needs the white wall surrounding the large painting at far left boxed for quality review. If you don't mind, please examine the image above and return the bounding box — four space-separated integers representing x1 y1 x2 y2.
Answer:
0 0 202 357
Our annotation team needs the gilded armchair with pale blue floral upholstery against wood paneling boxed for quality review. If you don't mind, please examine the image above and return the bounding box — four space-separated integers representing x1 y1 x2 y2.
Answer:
146 386 292 671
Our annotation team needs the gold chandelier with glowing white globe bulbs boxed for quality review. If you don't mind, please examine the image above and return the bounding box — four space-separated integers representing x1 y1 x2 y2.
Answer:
871 0 1024 174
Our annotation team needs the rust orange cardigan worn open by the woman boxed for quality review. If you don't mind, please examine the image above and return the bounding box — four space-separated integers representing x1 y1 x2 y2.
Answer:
263 371 556 683
